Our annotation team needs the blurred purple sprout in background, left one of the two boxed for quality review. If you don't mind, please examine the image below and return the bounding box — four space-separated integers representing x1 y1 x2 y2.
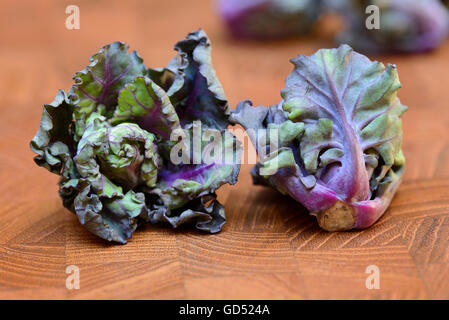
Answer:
217 0 321 39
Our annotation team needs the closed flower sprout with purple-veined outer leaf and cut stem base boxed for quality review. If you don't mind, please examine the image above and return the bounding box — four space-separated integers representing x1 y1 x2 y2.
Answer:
231 45 407 231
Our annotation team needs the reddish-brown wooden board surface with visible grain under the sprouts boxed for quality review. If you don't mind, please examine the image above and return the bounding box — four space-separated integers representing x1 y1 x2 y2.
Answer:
0 0 449 299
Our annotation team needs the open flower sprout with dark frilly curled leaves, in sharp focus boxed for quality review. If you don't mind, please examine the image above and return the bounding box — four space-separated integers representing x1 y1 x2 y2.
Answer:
31 30 241 243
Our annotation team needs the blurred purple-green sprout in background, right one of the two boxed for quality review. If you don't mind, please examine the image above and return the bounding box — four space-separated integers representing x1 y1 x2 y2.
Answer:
329 0 449 52
